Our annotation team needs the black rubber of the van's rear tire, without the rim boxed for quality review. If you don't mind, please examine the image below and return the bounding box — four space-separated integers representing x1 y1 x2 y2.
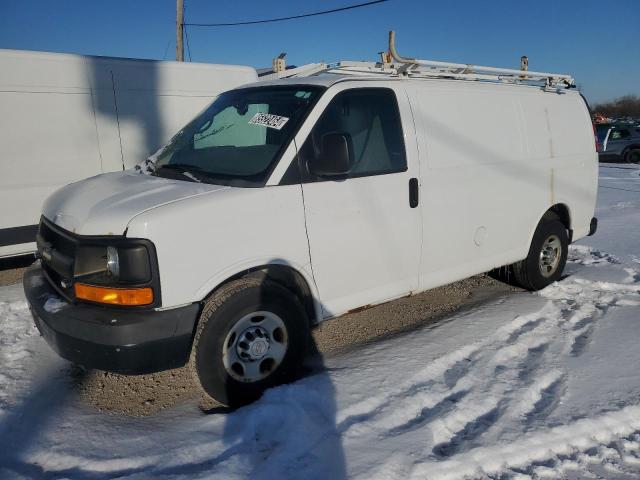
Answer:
513 214 569 290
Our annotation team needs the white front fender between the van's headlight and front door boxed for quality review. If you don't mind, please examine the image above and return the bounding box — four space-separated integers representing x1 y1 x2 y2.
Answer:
127 185 315 308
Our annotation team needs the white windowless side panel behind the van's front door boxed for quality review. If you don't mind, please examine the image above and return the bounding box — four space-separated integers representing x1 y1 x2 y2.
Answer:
408 81 596 289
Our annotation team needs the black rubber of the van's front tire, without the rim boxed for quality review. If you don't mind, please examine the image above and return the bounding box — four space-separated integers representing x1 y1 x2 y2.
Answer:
189 277 309 407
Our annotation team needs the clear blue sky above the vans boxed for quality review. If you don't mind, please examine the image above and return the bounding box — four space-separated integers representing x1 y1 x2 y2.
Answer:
0 0 640 102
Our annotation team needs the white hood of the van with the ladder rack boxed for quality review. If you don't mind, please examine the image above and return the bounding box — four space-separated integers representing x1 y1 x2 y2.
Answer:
42 171 228 235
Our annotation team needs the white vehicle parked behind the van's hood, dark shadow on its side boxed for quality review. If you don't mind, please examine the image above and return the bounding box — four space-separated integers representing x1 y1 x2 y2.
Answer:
0 50 257 258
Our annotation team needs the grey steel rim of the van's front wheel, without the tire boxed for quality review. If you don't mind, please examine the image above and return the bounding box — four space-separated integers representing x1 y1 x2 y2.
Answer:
222 311 289 383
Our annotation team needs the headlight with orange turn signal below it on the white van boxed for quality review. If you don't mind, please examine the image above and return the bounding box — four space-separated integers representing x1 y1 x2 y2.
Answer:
74 241 155 305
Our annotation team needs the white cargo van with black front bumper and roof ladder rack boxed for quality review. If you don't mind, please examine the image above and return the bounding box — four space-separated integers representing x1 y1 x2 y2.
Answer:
24 35 597 405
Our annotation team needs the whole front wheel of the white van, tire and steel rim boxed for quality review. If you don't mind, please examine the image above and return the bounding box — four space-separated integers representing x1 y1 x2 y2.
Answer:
189 277 309 407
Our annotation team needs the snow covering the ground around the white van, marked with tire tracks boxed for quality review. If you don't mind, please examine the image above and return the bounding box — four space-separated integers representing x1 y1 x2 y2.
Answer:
0 165 640 480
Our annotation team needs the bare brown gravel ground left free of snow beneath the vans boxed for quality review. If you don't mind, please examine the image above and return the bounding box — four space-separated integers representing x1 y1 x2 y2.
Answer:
0 262 516 416
